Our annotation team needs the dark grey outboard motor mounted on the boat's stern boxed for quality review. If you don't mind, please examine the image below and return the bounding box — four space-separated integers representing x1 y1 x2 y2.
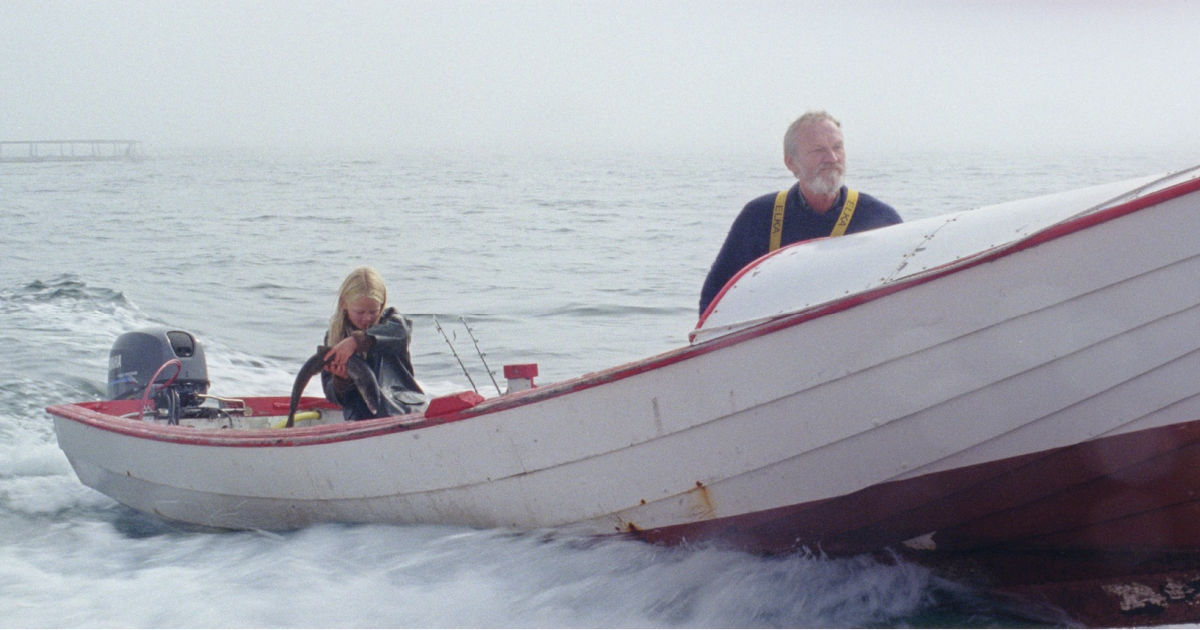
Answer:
108 328 209 424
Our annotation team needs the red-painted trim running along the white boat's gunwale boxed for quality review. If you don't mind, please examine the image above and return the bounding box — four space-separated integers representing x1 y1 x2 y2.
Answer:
46 167 1200 446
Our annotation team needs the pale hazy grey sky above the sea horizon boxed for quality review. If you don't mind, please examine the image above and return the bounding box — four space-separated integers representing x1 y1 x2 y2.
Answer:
0 0 1200 156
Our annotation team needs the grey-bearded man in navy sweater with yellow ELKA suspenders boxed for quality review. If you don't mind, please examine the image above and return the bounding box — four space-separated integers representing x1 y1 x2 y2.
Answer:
700 112 900 316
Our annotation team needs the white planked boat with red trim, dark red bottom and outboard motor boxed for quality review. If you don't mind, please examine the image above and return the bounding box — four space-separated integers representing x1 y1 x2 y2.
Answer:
48 168 1200 625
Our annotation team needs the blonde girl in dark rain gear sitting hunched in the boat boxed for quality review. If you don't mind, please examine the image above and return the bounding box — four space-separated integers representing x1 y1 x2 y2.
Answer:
320 266 425 420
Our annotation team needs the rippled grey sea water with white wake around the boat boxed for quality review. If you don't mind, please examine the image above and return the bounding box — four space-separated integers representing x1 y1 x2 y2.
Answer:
0 148 1200 628
